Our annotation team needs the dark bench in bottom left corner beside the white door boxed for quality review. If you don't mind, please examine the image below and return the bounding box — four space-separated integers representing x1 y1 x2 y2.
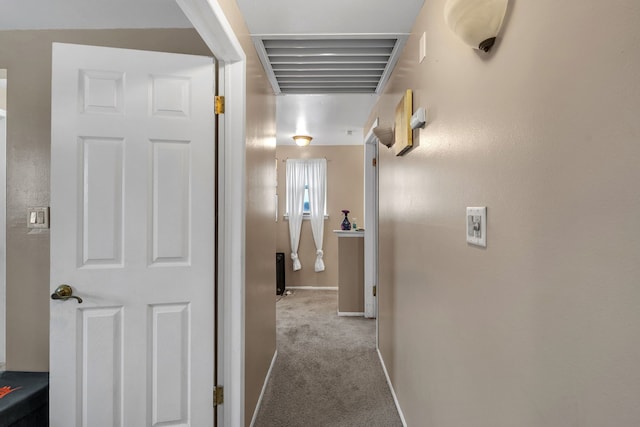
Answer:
0 371 49 427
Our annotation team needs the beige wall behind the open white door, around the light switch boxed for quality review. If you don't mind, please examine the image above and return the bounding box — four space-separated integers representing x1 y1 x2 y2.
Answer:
0 29 211 371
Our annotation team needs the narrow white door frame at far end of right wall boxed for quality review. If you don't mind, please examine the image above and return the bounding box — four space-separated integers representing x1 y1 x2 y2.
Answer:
364 119 378 320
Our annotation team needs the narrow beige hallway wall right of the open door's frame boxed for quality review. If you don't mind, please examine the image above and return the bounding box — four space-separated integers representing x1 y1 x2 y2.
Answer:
215 0 276 425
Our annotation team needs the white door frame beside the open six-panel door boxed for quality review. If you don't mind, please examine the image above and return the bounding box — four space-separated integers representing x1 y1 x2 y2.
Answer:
176 0 246 427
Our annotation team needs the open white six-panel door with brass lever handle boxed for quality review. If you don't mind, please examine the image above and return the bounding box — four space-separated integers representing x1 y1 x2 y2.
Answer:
50 43 215 427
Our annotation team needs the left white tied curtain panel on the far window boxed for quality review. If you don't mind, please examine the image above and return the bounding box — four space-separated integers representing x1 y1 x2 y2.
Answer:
287 159 306 271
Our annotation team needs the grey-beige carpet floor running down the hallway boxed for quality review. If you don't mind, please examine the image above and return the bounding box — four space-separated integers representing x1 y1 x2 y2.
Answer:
254 289 402 427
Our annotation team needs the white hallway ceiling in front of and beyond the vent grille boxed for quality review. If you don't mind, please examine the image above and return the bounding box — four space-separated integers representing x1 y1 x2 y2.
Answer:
237 0 424 145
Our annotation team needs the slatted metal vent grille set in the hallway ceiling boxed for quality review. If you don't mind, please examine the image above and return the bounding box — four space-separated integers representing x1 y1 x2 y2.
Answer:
254 35 406 94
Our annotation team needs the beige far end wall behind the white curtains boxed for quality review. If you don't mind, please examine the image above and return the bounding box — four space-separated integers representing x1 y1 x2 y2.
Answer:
276 143 364 286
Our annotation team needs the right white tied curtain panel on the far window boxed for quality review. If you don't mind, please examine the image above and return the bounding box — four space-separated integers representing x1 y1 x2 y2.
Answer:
307 159 327 272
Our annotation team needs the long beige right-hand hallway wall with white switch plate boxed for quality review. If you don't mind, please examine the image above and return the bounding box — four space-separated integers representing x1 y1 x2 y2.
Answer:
365 0 640 427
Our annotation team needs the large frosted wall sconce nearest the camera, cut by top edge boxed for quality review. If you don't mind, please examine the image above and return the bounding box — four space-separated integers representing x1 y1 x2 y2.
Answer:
444 0 508 52
